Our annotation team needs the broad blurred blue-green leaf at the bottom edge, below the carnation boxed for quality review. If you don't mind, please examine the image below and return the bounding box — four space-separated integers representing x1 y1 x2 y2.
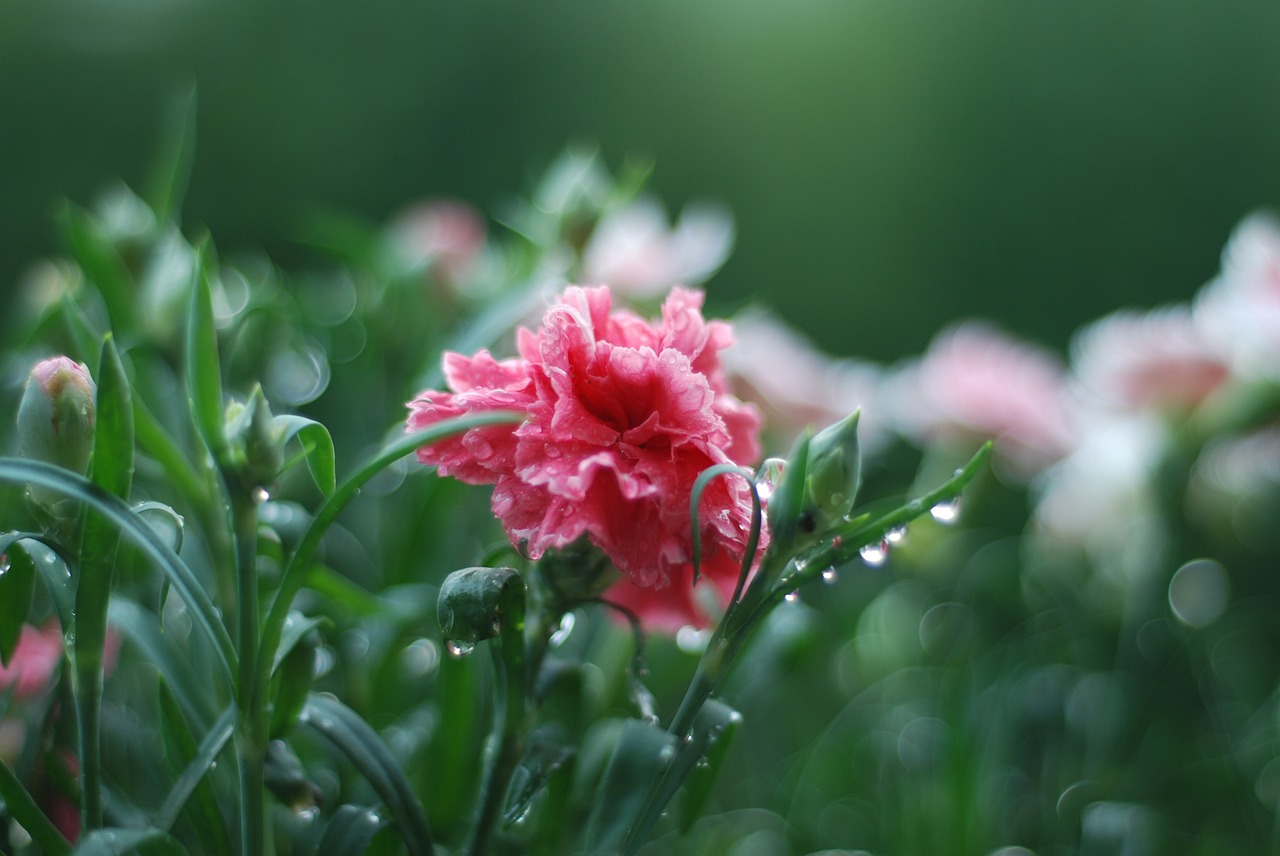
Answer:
586 719 676 856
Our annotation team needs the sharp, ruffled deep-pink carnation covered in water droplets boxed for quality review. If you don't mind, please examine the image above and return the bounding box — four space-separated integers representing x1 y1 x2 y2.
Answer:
408 287 760 628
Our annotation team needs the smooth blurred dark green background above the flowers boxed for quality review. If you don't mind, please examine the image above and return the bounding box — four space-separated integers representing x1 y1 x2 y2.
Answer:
0 0 1280 360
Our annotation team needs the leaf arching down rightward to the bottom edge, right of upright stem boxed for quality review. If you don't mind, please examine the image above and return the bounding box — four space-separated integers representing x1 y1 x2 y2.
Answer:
301 694 433 856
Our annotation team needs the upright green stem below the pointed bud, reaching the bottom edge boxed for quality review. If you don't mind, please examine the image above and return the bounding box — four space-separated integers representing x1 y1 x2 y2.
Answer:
230 489 266 856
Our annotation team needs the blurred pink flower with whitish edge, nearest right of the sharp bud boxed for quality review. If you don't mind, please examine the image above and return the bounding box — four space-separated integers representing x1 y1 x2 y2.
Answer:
882 322 1073 477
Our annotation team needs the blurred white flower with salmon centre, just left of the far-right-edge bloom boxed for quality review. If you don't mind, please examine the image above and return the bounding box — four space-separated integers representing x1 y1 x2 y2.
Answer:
1073 306 1230 411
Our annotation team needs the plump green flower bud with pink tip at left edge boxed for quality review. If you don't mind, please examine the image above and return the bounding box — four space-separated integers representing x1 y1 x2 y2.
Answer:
18 357 96 511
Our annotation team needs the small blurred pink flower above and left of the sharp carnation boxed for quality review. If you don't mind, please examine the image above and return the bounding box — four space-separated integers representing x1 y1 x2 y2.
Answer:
392 200 485 285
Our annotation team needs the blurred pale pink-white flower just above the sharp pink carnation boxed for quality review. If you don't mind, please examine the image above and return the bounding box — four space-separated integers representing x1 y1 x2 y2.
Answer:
582 198 733 297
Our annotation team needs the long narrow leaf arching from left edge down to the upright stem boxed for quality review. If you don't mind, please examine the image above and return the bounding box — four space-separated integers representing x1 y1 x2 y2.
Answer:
0 458 237 677
